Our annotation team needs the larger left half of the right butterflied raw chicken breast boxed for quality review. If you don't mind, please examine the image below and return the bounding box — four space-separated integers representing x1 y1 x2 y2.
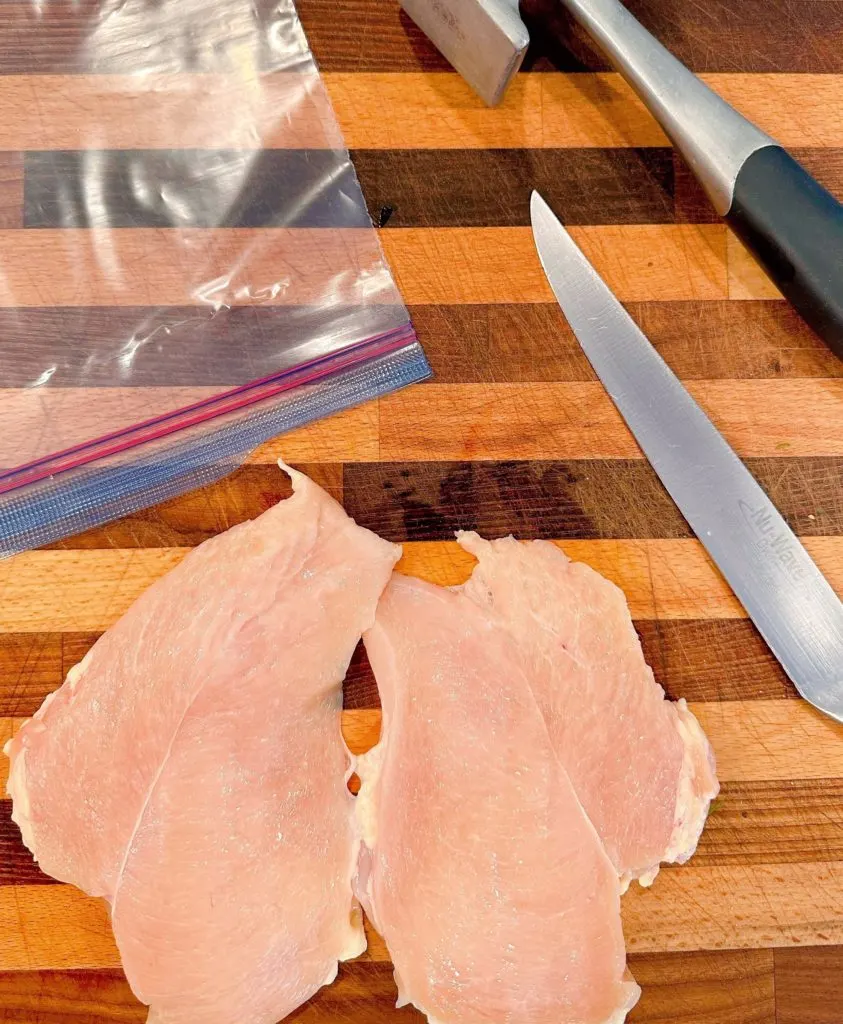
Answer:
357 575 638 1024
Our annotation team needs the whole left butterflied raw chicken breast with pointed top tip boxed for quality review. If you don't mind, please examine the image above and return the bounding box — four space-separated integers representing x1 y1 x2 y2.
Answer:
4 471 399 1024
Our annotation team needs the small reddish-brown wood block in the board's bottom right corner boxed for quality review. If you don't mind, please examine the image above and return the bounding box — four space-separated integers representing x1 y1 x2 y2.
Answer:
773 946 843 1024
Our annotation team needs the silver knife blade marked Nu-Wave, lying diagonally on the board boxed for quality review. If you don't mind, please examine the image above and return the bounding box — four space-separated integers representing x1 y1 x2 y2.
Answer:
531 191 843 722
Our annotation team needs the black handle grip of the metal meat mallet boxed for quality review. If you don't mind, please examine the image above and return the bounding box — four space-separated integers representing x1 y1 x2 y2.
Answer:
726 145 843 358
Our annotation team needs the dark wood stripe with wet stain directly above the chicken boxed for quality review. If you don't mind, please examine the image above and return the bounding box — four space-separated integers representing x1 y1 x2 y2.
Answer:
16 456 843 550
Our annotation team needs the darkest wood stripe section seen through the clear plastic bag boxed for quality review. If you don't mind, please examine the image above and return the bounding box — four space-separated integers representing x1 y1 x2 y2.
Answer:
20 150 366 227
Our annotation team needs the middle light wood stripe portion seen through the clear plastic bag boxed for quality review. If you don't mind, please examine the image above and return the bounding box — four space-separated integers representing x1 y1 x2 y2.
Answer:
0 230 398 308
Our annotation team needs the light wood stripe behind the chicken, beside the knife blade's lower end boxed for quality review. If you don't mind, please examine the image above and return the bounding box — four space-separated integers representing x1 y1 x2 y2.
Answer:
6 700 843 795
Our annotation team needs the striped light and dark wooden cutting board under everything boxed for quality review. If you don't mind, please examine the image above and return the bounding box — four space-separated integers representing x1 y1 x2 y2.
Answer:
0 0 843 1024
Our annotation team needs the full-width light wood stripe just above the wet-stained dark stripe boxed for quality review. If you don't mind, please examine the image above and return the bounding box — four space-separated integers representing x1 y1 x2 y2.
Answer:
6 378 843 466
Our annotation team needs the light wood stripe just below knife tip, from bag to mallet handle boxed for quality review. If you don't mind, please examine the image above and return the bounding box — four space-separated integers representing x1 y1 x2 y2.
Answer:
0 226 811 308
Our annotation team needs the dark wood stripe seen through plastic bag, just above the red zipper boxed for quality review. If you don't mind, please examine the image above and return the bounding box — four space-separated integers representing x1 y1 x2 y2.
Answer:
0 305 405 388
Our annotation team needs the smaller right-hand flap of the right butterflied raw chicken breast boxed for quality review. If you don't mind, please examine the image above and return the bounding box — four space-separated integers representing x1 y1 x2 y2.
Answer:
458 534 718 885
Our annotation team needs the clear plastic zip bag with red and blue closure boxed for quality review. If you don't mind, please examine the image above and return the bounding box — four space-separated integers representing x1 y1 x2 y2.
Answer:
0 0 429 553
